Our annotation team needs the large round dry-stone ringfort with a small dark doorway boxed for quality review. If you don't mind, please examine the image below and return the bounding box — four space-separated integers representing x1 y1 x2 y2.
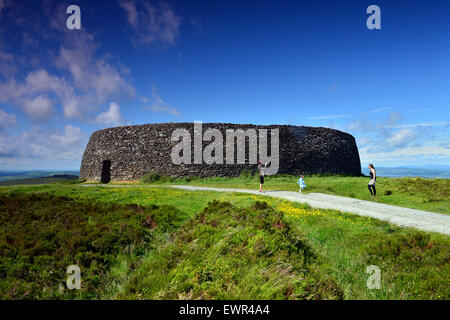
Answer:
80 123 361 182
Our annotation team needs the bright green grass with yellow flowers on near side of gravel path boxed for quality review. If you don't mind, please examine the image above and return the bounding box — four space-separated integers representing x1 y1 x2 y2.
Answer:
0 184 450 299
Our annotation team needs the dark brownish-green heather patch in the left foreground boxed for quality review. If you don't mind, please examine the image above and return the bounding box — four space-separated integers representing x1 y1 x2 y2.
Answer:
0 193 182 299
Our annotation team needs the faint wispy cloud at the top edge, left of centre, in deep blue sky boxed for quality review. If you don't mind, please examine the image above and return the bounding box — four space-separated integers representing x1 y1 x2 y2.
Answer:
119 0 182 45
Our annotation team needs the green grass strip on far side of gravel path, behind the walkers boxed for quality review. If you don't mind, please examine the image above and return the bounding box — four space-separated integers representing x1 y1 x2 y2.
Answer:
136 174 450 214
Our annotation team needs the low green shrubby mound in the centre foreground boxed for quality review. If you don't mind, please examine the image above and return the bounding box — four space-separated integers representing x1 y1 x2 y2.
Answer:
119 201 343 299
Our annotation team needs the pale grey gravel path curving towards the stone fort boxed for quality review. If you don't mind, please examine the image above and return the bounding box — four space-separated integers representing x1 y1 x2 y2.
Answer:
81 185 450 235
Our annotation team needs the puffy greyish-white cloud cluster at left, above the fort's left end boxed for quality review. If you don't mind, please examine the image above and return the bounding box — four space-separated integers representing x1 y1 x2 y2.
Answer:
0 33 134 122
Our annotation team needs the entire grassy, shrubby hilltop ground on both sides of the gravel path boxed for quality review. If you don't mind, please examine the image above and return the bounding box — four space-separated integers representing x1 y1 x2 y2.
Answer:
0 175 450 299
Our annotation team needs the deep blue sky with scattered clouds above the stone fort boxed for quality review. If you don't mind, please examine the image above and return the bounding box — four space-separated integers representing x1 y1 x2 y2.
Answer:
0 0 450 170
